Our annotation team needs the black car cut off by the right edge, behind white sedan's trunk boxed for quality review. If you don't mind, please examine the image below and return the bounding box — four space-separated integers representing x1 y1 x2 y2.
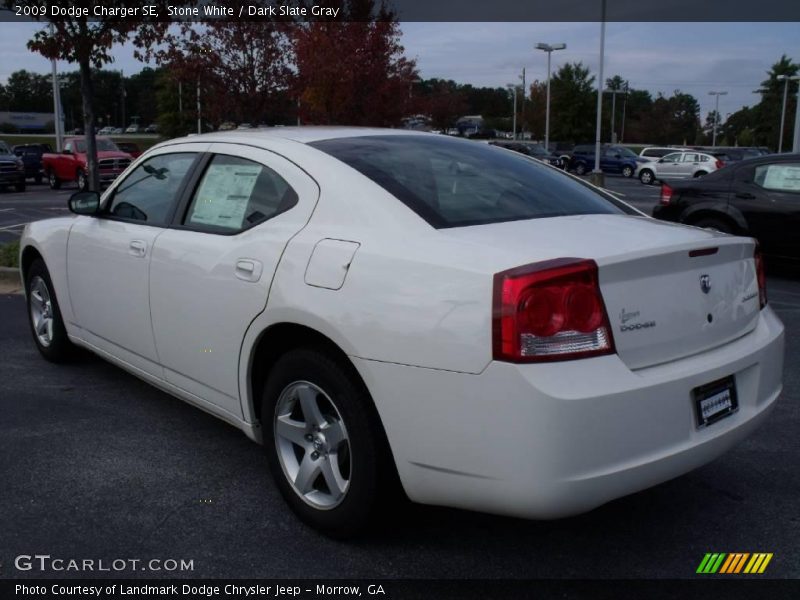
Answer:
653 154 800 259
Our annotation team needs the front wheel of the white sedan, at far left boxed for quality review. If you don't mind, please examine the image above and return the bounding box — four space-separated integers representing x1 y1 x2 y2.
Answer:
25 258 75 362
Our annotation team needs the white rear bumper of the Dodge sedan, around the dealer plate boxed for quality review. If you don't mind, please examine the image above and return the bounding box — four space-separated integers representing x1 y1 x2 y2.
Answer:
353 308 784 518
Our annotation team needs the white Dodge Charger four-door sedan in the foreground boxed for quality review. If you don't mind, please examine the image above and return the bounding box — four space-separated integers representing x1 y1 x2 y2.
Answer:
21 128 784 536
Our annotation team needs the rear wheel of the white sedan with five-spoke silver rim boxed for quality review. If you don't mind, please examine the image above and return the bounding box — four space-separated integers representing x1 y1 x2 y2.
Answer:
261 349 394 538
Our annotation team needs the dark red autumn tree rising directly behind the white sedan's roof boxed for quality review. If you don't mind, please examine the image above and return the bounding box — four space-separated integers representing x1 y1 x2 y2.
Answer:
293 0 417 126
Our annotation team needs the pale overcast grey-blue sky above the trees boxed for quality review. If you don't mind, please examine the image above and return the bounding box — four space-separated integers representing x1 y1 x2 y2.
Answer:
0 23 800 117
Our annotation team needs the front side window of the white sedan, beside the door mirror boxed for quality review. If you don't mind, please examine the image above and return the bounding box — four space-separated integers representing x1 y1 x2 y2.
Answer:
106 152 197 225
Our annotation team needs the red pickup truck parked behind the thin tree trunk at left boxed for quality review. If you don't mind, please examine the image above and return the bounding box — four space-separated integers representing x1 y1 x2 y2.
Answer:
42 137 132 190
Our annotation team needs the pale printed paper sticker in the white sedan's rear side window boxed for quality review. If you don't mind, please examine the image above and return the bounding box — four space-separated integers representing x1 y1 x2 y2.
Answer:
189 164 262 229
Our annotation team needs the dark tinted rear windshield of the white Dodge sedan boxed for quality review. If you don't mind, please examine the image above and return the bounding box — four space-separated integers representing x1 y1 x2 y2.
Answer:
311 135 632 228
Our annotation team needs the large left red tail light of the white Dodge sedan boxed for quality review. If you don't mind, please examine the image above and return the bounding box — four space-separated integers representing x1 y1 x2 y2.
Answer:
492 258 614 363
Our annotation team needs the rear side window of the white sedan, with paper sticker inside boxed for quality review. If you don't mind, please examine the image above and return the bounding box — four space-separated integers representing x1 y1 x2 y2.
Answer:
183 154 297 233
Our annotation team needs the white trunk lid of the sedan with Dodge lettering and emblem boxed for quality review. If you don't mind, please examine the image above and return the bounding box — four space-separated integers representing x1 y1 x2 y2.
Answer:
446 215 760 369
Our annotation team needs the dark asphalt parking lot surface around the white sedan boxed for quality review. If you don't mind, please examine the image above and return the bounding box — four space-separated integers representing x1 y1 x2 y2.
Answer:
0 178 800 579
